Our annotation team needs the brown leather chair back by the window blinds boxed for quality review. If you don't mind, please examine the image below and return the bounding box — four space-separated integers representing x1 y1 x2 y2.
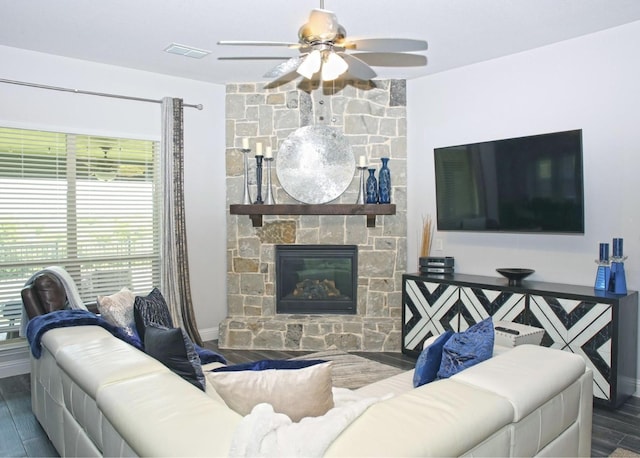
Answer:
21 272 67 319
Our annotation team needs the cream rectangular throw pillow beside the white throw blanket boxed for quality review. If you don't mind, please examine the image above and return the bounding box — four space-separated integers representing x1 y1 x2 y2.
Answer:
207 361 334 422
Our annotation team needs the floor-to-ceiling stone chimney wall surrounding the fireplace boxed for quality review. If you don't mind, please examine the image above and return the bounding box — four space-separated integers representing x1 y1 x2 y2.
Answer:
219 80 407 351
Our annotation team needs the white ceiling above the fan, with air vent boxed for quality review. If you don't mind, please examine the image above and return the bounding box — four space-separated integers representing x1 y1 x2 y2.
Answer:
0 0 640 83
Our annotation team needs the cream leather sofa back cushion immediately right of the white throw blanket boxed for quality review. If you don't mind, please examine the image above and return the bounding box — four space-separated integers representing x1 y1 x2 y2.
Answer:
325 379 513 457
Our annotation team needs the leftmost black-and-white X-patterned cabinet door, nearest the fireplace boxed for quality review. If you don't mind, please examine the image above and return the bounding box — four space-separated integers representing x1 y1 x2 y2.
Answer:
403 280 458 351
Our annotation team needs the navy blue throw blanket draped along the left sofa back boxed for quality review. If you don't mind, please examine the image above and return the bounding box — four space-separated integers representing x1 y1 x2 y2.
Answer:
27 309 227 364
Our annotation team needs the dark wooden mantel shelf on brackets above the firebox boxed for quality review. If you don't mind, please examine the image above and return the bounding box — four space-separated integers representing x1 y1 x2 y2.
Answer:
229 204 396 227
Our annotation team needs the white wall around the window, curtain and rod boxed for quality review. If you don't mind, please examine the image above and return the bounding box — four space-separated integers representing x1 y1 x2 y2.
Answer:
0 46 227 340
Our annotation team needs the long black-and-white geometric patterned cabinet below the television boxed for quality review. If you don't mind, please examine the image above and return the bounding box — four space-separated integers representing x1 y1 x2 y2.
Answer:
402 274 638 408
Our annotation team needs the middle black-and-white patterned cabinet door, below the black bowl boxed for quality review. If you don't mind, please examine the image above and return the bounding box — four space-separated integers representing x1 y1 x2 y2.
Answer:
460 286 526 330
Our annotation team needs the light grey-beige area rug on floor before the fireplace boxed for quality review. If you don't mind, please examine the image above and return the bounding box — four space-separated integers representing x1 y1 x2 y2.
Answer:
291 350 404 389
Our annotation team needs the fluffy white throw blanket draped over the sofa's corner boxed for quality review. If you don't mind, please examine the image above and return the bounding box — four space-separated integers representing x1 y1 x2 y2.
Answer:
229 388 391 458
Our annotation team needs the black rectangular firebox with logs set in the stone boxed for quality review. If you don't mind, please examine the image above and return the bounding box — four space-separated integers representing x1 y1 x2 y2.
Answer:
275 245 358 315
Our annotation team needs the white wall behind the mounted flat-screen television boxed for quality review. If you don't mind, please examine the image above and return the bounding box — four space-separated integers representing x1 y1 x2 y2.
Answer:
407 22 640 390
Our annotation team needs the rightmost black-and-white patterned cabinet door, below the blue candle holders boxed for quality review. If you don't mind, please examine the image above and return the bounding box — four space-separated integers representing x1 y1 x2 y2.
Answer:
530 295 613 400
